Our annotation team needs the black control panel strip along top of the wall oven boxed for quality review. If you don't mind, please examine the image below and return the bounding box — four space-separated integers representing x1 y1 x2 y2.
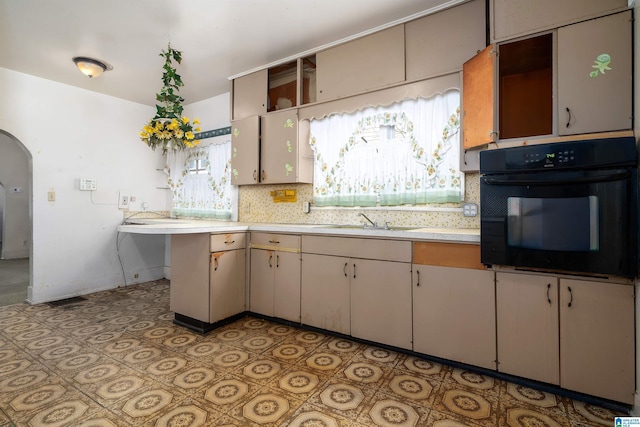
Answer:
480 137 637 174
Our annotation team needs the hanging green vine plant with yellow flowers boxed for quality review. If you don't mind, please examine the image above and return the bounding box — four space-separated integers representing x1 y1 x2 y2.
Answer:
140 45 200 154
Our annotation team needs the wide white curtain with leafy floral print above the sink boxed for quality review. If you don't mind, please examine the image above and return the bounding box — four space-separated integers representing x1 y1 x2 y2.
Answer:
311 90 464 206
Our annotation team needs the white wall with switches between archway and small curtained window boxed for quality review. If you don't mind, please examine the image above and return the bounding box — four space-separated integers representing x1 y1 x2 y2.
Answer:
0 68 168 303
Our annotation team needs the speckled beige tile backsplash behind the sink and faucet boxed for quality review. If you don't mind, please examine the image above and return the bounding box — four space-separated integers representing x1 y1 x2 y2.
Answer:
238 174 480 228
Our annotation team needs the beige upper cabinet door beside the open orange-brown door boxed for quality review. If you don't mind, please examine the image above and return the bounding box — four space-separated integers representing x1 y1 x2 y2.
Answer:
405 0 486 81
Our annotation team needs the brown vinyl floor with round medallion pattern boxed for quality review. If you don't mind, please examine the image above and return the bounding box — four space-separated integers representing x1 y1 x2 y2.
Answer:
0 281 622 427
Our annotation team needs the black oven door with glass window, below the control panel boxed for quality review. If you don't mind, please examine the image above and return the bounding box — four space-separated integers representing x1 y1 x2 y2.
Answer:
480 169 638 277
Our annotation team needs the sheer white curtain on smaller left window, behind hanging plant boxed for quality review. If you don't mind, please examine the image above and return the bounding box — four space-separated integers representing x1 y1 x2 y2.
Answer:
167 135 237 220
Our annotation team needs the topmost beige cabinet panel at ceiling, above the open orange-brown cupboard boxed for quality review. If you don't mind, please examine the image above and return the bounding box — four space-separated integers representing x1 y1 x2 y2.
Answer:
490 0 628 41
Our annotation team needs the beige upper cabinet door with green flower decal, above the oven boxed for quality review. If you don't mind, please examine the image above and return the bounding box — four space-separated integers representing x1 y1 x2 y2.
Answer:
558 11 633 135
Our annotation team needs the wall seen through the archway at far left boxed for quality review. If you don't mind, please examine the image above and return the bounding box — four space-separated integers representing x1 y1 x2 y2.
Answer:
0 132 31 259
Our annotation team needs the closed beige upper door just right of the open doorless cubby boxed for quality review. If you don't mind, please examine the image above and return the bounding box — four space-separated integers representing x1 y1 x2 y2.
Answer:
316 25 405 101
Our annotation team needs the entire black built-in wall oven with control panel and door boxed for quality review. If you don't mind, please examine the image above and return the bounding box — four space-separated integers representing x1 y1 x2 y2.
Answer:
480 137 638 277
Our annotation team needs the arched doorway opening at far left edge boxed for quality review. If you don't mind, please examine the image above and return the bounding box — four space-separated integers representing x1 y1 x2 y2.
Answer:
0 130 33 306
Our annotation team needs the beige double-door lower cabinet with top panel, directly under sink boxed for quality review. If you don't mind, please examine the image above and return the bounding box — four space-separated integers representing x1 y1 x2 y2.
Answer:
301 236 412 349
